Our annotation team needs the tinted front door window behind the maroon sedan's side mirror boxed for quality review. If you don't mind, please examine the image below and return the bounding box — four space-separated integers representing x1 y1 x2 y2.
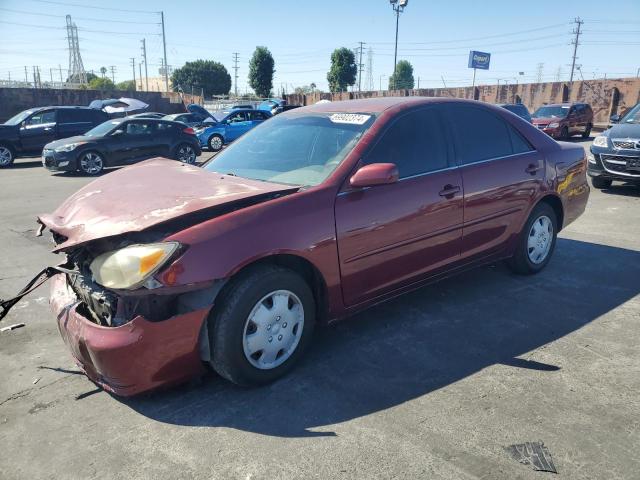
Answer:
365 109 448 178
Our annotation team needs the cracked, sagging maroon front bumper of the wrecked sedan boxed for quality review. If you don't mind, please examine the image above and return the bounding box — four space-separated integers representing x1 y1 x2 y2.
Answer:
50 274 211 396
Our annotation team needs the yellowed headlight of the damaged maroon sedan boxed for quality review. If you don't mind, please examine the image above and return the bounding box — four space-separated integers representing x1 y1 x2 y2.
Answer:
89 242 180 289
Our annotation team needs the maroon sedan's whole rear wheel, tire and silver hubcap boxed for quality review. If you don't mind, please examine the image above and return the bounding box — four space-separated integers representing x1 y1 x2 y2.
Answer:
508 203 558 275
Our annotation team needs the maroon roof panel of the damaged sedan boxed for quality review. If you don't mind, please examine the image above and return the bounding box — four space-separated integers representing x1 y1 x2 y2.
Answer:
298 97 489 114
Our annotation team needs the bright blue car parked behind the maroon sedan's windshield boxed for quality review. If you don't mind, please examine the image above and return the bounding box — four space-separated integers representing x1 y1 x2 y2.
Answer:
196 109 271 152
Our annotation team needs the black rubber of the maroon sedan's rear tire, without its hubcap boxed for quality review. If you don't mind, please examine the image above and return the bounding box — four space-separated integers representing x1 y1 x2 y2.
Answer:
507 202 558 275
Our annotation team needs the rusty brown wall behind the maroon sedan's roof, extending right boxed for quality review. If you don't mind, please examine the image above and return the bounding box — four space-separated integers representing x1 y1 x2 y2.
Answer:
287 78 640 124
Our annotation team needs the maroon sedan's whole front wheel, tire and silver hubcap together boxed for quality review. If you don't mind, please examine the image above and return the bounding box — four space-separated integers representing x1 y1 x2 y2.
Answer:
208 266 315 386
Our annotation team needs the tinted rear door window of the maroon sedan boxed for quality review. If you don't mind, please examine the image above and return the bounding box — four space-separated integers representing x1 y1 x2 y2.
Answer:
450 106 533 165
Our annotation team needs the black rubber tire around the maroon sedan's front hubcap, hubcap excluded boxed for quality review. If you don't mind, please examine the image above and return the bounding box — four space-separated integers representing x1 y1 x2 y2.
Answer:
208 266 315 386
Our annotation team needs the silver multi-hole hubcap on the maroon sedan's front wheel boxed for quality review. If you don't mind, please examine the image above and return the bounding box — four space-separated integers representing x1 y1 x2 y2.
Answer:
242 290 304 370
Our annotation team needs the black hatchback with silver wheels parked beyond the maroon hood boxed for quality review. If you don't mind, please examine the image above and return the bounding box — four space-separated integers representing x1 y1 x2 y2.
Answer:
42 118 202 175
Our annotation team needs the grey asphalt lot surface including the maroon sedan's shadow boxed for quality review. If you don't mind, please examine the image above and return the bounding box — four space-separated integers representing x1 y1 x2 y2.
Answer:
0 140 640 480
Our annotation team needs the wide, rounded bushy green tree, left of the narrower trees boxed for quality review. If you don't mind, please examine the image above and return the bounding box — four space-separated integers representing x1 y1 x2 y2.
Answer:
171 60 231 96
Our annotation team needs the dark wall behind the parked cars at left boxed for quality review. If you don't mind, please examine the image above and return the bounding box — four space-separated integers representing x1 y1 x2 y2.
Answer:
0 88 201 122
